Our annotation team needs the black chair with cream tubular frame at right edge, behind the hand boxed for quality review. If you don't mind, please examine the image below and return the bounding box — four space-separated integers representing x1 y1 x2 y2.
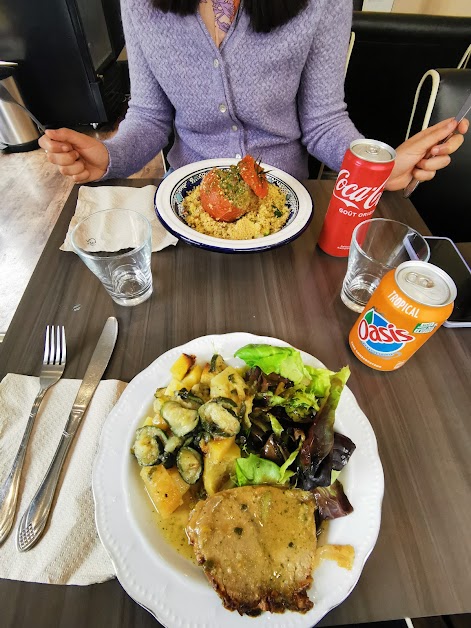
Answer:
406 68 471 242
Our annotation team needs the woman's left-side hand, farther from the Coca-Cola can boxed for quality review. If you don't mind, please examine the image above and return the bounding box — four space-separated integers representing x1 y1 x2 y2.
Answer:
39 129 110 183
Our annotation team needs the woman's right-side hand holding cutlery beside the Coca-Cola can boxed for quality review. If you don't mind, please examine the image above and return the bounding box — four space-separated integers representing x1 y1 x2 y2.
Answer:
386 118 469 190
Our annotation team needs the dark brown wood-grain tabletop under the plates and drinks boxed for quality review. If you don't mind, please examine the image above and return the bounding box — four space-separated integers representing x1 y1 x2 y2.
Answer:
0 180 471 628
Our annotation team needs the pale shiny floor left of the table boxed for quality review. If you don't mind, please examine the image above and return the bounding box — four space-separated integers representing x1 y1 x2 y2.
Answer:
0 123 163 340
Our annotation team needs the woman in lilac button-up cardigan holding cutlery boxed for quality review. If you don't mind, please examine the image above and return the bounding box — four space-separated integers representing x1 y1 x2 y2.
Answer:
40 0 468 190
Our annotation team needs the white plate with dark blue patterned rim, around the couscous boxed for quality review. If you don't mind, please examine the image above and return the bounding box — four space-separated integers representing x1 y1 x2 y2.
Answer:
155 159 312 253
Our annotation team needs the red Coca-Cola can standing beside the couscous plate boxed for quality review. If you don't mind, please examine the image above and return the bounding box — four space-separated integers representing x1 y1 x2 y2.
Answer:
317 139 396 257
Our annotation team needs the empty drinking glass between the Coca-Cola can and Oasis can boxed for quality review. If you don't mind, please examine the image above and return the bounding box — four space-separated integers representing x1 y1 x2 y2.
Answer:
340 218 430 312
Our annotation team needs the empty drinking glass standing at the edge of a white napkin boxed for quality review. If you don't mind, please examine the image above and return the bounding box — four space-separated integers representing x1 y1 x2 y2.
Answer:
70 209 152 306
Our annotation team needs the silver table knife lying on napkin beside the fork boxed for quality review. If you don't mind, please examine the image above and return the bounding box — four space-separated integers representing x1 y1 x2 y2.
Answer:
16 316 118 552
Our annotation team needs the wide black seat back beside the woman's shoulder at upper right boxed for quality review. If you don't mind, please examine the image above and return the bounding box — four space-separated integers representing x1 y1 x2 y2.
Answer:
345 11 471 147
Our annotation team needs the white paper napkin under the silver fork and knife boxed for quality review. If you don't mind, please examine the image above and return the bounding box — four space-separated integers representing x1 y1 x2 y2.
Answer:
0 373 126 585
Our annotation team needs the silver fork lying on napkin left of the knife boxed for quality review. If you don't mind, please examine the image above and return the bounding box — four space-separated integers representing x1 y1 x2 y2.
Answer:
0 325 66 545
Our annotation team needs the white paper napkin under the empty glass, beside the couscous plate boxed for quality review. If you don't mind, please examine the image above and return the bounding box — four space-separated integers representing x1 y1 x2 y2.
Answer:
60 185 178 251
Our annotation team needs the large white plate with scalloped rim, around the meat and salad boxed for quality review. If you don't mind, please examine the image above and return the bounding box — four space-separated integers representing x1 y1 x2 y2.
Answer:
93 333 384 628
